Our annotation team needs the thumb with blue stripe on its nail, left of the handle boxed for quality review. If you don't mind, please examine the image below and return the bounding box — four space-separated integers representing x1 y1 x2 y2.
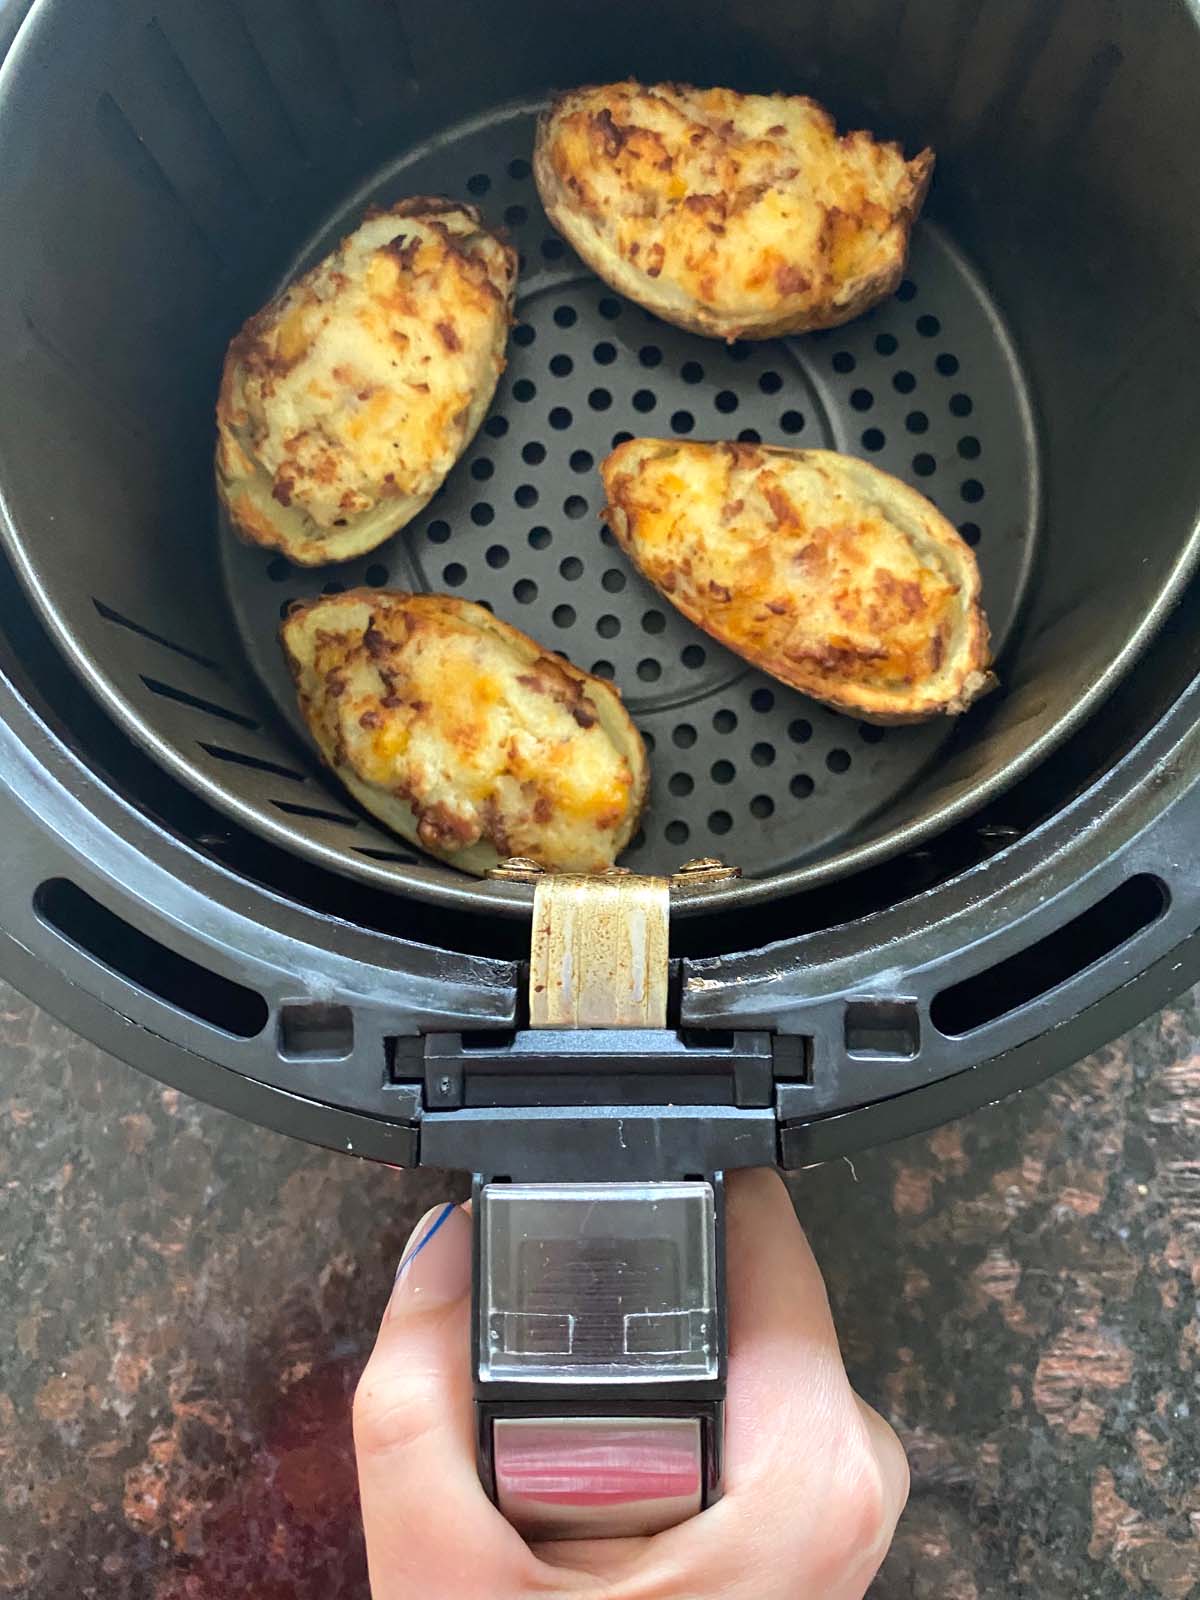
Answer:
354 1205 531 1600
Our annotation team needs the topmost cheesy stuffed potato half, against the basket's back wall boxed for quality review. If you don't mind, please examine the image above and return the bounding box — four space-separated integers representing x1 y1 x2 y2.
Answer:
533 83 933 339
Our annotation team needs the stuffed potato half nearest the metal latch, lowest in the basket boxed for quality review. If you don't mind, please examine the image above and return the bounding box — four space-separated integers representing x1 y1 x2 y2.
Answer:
280 589 648 874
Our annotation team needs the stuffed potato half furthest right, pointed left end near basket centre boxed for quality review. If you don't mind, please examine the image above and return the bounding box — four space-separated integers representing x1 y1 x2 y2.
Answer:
600 438 992 722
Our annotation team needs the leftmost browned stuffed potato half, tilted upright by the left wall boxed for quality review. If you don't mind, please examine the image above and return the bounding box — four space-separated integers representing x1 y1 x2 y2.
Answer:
216 197 517 566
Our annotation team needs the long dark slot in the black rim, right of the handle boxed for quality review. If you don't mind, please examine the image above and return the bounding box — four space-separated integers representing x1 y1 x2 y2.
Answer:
930 874 1168 1038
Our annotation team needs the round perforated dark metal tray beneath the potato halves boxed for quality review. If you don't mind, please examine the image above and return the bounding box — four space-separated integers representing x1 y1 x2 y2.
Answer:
216 107 1038 878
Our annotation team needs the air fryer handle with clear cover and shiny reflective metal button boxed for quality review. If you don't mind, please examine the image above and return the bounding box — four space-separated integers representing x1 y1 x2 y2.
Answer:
472 1176 725 1539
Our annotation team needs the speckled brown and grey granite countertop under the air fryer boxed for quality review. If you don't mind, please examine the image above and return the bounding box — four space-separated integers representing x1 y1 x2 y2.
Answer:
0 987 1200 1600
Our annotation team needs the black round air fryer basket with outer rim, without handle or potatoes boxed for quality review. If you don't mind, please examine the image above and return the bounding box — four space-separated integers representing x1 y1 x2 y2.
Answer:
0 0 1200 1178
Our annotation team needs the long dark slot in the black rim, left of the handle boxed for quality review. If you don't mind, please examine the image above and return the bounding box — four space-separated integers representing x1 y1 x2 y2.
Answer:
34 878 267 1038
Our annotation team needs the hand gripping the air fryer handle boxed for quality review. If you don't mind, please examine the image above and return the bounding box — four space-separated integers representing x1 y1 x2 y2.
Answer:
354 1171 909 1600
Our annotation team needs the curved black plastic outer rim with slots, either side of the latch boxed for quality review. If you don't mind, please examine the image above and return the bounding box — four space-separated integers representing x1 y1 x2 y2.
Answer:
0 636 1200 1165
